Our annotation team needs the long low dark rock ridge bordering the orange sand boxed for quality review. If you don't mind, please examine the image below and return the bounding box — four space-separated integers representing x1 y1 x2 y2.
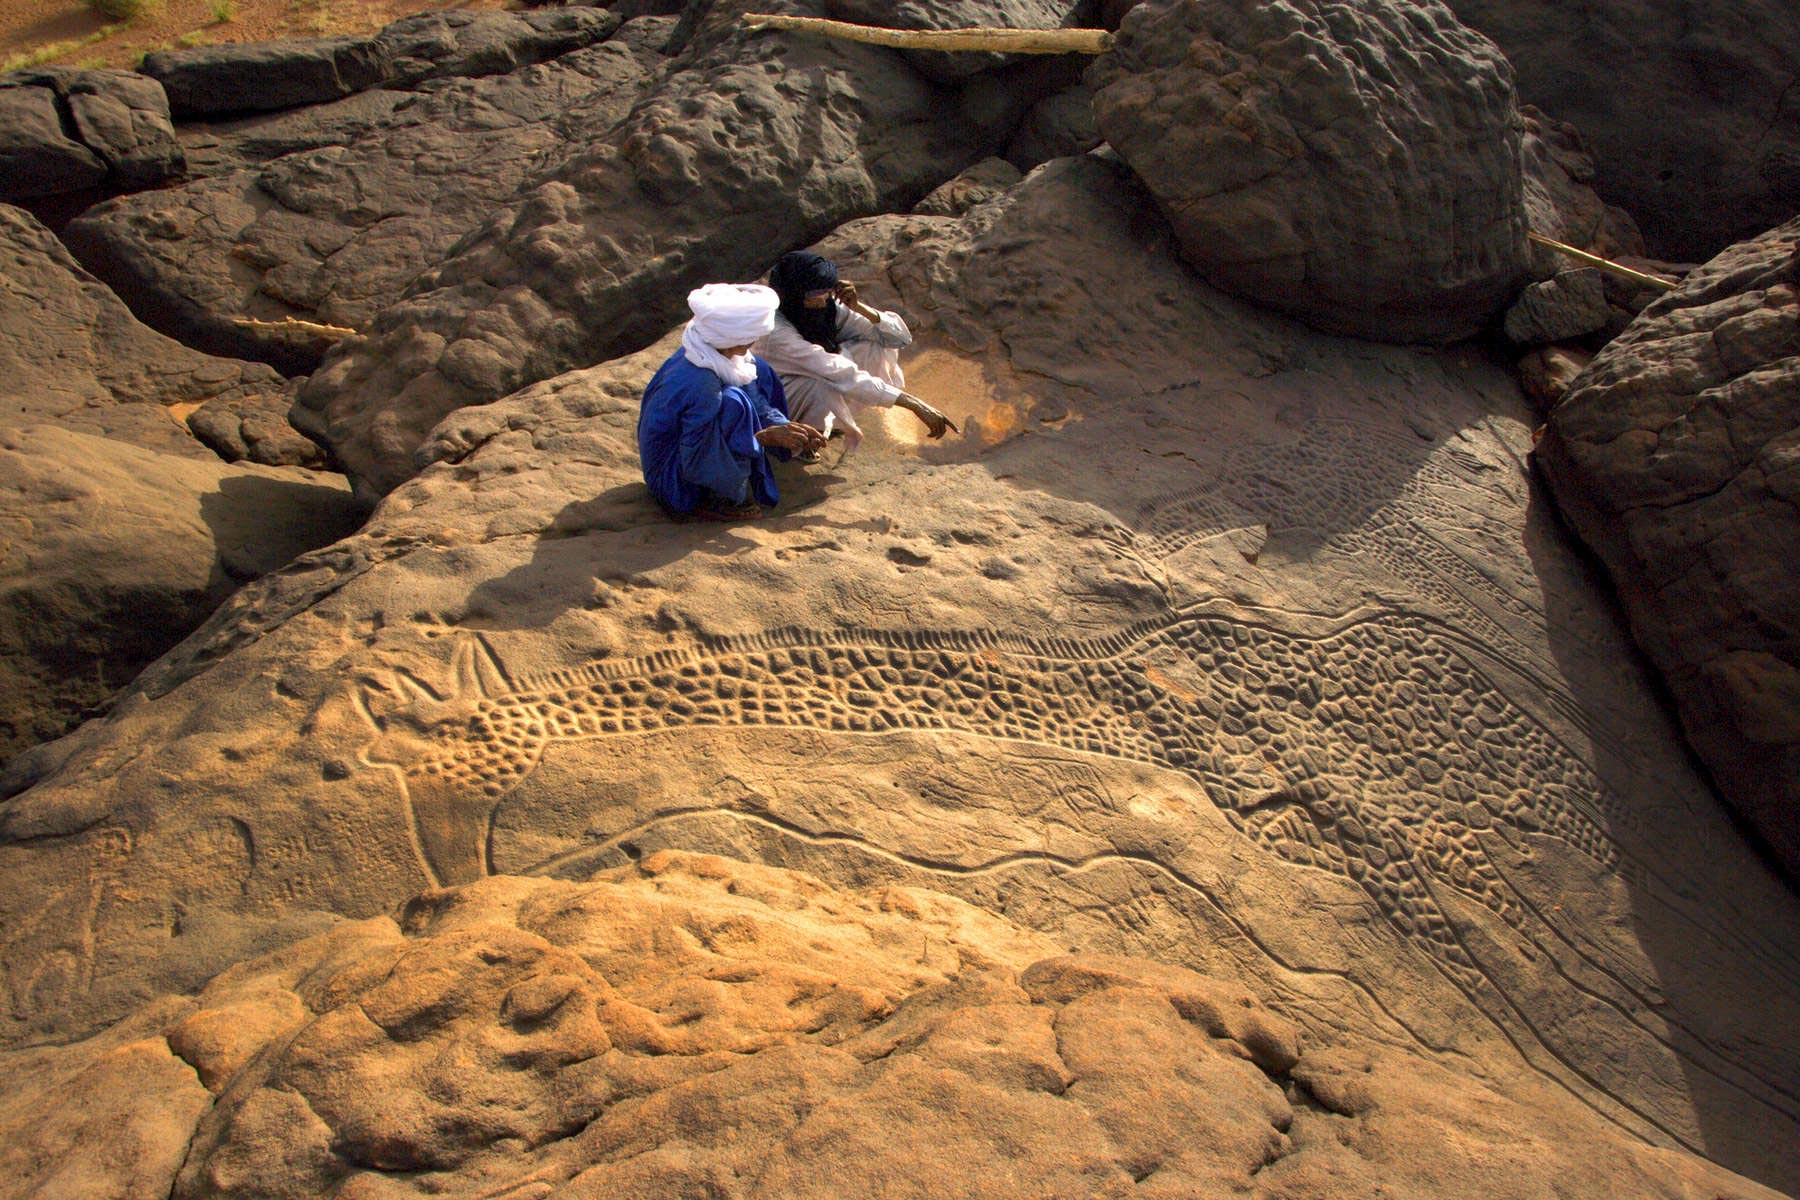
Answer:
142 7 619 119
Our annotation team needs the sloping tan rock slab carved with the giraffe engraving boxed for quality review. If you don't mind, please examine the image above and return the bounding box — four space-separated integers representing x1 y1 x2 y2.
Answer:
0 158 1800 1195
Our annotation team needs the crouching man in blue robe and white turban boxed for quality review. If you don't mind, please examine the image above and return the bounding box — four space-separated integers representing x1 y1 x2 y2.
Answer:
637 284 824 520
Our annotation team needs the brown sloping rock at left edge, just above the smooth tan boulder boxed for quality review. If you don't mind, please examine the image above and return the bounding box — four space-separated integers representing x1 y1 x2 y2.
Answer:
0 205 284 459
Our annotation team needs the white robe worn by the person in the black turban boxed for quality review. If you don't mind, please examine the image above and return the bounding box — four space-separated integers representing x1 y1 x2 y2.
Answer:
754 304 913 450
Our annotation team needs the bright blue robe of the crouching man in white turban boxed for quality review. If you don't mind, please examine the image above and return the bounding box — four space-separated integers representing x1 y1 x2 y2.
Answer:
637 351 788 513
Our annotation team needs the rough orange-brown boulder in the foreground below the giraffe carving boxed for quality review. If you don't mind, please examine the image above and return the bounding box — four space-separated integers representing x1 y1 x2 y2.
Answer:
0 853 1778 1200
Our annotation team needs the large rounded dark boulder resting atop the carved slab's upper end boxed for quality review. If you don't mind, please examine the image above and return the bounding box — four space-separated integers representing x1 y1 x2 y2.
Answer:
1091 0 1526 342
